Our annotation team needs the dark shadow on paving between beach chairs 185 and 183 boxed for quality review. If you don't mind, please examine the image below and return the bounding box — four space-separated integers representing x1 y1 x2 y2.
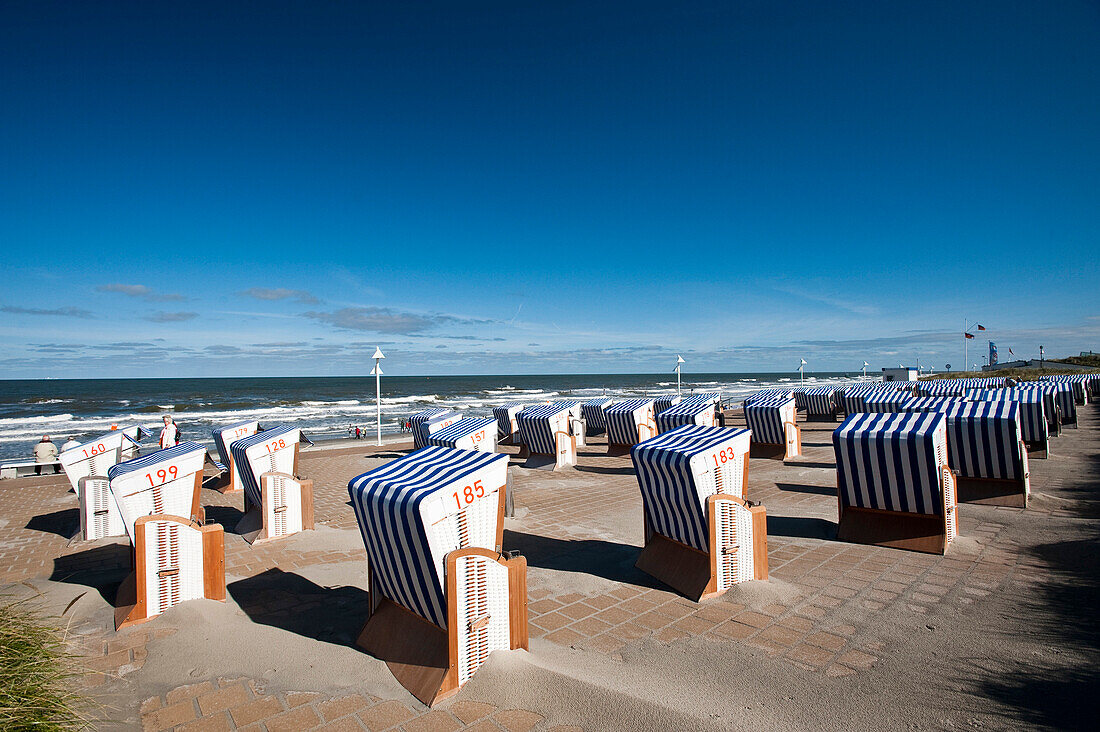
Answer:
504 528 667 589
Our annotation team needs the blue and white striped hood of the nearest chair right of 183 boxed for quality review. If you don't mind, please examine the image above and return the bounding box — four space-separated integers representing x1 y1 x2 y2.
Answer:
833 412 947 515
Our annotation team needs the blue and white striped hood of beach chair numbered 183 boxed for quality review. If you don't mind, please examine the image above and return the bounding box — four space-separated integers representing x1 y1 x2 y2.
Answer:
630 425 748 551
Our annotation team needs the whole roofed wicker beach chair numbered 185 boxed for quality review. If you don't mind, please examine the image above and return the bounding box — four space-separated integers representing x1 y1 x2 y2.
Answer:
348 446 528 704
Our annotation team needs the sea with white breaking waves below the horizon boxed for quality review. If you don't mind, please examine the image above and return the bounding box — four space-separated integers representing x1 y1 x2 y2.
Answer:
0 373 858 460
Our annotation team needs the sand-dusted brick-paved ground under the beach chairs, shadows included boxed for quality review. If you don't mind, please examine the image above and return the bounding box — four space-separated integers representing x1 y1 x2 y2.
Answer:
0 406 1100 732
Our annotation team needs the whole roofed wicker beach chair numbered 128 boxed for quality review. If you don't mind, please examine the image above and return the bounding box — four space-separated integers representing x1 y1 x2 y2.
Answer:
229 425 314 544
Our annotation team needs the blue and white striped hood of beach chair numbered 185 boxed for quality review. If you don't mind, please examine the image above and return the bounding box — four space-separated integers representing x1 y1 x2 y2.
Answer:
348 446 508 627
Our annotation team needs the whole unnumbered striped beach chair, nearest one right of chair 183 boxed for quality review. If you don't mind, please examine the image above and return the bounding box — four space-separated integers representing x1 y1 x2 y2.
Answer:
833 412 957 554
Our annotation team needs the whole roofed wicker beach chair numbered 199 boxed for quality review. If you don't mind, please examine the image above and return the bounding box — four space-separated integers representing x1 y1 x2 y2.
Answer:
108 443 226 629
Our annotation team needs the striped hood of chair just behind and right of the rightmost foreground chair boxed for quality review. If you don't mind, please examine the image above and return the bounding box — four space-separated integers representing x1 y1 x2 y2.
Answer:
944 402 1024 480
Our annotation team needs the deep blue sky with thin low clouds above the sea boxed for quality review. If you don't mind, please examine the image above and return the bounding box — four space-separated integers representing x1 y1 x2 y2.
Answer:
0 1 1100 378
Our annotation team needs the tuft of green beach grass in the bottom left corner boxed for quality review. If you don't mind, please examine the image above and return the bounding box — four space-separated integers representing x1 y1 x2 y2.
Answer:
0 598 90 731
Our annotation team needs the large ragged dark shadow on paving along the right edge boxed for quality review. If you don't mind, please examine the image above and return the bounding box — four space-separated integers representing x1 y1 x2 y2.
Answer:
963 444 1100 729
